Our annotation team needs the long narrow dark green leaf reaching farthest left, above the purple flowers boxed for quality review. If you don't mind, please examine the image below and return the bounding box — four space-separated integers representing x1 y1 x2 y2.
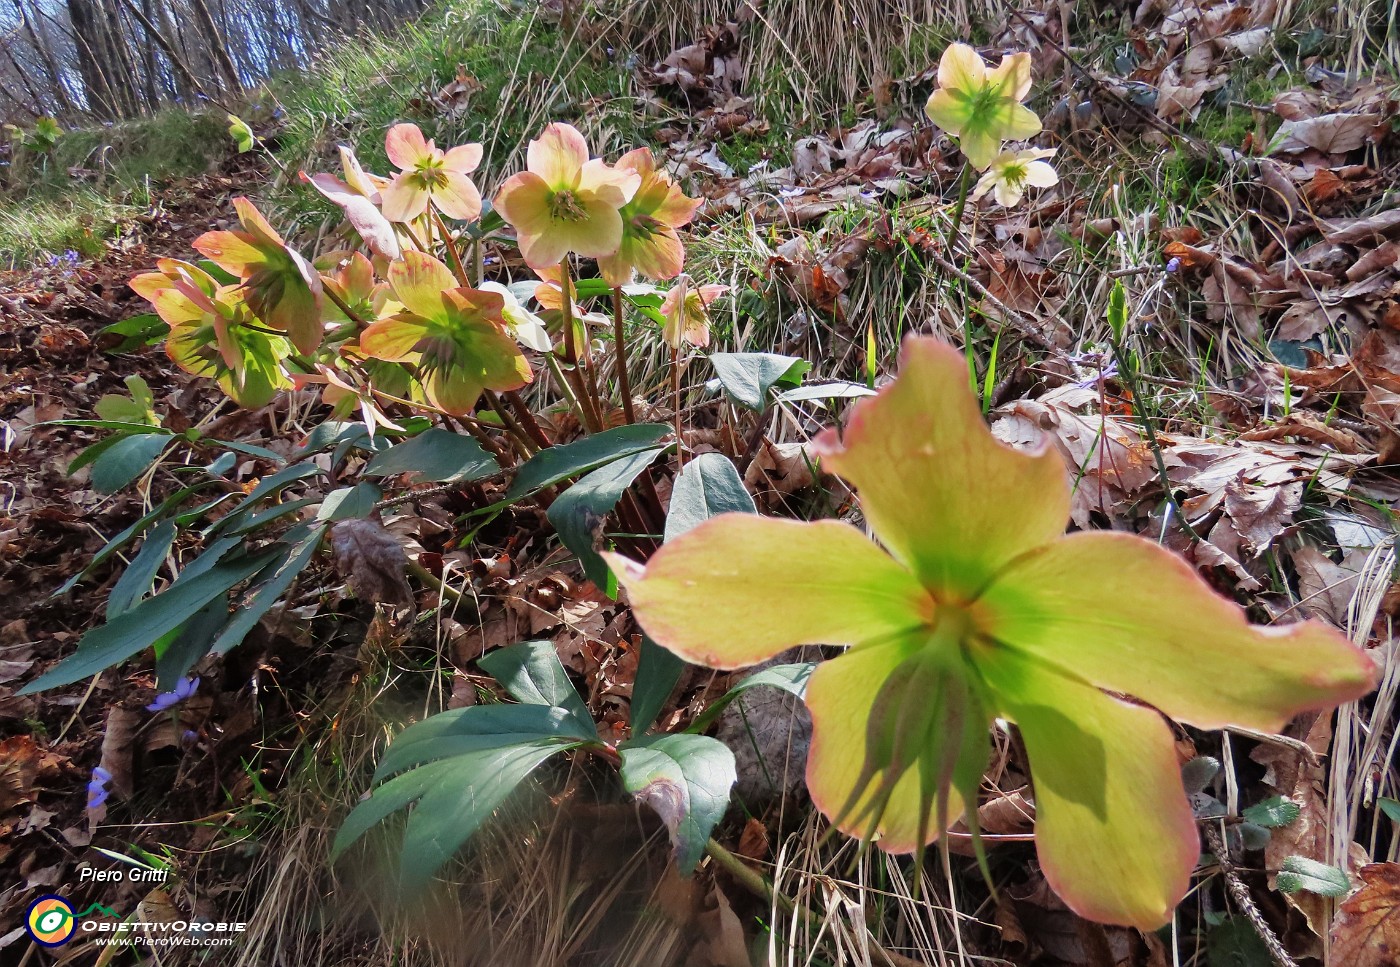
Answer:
20 554 274 696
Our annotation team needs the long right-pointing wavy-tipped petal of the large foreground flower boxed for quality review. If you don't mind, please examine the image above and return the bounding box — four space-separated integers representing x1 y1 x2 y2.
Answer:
977 532 1375 732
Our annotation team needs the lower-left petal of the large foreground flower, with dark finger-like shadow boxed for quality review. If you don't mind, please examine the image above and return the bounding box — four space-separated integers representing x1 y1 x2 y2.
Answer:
805 634 988 852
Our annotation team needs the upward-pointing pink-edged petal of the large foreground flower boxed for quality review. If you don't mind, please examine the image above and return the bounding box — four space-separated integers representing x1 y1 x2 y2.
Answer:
818 339 1070 596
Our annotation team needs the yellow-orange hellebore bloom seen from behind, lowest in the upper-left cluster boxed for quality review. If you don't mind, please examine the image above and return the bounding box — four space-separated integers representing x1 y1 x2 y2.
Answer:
360 252 532 416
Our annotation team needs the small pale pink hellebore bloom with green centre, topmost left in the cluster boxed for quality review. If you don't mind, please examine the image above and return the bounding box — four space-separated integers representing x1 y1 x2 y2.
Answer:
379 125 482 221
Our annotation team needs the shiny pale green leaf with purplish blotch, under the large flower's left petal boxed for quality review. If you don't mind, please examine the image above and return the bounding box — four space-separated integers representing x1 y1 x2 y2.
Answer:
620 733 735 876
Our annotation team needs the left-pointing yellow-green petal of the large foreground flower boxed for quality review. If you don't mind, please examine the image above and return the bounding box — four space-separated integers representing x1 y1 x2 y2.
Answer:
608 514 932 669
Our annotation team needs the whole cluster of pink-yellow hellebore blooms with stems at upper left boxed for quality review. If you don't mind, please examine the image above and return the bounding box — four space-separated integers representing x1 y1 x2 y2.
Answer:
123 123 699 453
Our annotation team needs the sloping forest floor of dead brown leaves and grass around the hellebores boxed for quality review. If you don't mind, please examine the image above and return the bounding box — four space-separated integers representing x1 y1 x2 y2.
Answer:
0 0 1400 967
